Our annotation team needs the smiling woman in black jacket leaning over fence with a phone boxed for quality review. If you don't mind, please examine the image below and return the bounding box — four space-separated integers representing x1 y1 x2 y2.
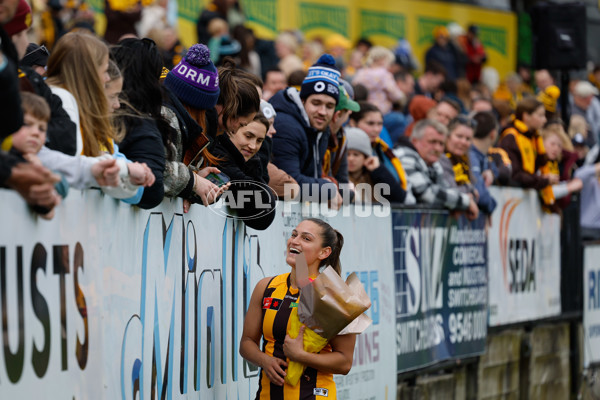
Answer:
209 112 277 230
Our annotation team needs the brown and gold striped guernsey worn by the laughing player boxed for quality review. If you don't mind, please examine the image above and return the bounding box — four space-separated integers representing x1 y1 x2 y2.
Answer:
256 273 336 400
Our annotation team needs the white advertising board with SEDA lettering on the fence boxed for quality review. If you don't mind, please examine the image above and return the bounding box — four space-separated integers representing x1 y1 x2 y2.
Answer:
488 187 561 326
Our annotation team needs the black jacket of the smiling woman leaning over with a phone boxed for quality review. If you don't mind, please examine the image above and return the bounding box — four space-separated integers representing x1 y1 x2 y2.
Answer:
213 133 277 230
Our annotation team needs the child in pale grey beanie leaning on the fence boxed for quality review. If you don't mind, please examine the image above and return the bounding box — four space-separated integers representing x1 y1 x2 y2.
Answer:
345 128 406 204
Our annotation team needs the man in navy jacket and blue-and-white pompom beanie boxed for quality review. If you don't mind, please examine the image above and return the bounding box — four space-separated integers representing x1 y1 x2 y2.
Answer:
270 54 342 207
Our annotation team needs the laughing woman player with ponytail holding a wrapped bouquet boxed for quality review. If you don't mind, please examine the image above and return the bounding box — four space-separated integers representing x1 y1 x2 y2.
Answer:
240 218 356 400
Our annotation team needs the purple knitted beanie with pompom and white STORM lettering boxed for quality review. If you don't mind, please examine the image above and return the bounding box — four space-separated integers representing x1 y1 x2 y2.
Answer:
164 44 220 110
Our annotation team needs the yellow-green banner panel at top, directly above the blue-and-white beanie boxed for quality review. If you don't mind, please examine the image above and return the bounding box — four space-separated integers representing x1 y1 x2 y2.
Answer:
298 2 350 37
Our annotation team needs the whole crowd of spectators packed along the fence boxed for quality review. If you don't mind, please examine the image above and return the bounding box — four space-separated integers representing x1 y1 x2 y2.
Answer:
0 0 600 236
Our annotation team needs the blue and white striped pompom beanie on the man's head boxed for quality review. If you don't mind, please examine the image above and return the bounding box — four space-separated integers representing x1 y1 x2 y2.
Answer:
300 54 340 104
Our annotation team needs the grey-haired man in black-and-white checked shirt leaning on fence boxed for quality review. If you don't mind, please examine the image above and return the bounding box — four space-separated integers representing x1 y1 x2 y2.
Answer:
394 119 479 219
